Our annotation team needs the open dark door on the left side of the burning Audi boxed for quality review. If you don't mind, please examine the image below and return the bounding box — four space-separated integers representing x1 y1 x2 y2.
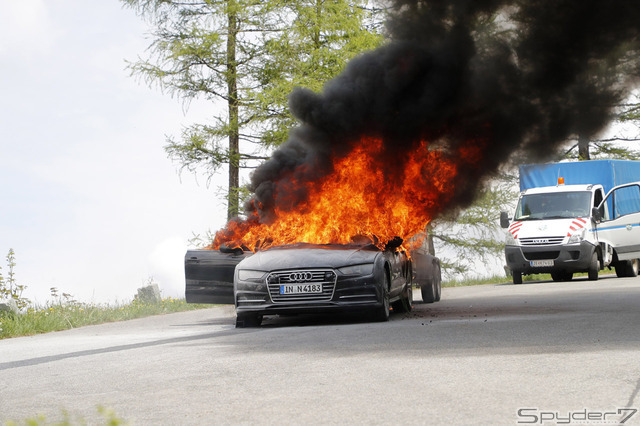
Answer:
184 250 253 304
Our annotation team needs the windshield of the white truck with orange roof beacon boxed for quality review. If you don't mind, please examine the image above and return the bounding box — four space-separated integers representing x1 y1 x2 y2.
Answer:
514 191 591 220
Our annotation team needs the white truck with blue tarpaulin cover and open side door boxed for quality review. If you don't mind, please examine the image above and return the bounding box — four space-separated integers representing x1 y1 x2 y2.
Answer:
500 160 640 284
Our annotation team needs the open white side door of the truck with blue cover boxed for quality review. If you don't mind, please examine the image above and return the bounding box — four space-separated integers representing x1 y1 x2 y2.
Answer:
596 182 640 260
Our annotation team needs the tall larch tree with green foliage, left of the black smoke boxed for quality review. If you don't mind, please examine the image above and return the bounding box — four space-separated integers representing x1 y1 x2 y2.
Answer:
122 0 382 219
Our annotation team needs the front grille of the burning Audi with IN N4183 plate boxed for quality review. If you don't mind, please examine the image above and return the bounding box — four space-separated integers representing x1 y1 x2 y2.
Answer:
267 269 338 303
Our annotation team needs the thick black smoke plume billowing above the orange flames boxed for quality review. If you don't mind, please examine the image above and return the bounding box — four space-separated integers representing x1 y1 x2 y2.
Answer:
242 0 640 228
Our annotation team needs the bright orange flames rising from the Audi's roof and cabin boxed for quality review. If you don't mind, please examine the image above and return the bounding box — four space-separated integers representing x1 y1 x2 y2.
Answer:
211 138 482 251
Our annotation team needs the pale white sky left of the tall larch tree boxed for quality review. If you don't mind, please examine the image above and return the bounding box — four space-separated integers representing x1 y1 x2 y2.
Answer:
0 0 227 304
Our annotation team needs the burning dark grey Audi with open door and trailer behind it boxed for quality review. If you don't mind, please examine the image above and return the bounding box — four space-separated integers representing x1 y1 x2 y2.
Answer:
185 239 441 327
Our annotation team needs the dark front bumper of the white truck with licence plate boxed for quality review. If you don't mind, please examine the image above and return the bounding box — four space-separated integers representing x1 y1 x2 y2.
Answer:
504 241 596 274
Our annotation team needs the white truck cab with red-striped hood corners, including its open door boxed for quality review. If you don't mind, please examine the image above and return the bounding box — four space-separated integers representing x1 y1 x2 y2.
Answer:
501 180 640 284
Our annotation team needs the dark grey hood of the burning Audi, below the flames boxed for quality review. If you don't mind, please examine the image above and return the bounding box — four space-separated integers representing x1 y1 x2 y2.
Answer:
237 244 381 271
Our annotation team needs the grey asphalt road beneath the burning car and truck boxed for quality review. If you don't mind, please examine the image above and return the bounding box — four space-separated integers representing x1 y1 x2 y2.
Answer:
0 277 640 425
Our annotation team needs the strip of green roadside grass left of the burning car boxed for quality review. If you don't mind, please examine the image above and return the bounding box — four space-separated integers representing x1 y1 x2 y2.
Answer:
0 297 211 339
